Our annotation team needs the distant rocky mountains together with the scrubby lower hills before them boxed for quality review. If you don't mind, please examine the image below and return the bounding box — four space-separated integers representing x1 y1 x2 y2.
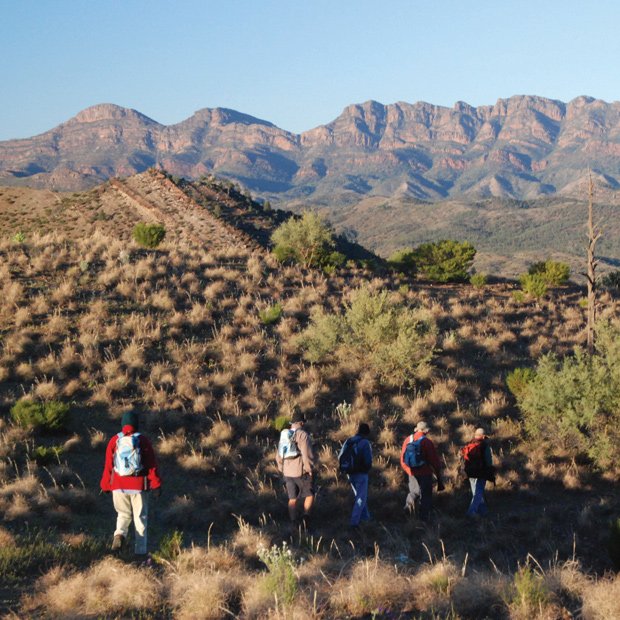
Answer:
0 96 620 274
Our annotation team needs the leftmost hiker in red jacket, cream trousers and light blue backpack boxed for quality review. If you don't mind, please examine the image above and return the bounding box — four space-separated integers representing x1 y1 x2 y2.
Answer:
100 411 161 558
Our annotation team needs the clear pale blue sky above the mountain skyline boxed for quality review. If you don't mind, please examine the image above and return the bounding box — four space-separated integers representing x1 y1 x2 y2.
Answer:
0 0 620 140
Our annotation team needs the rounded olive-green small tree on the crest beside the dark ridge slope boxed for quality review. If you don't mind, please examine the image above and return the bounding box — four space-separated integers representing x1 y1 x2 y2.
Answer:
271 211 335 267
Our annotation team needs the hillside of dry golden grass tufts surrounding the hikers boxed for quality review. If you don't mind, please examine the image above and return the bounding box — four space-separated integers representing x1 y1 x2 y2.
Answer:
0 173 620 619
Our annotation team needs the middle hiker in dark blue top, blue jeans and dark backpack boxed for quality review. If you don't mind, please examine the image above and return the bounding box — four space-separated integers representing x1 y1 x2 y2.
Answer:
338 422 372 528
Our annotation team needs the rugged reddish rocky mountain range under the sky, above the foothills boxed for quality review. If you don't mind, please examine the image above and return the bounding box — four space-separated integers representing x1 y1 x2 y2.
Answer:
0 96 620 202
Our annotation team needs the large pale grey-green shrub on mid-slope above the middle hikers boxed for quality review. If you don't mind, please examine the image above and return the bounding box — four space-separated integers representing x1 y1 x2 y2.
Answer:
299 288 436 385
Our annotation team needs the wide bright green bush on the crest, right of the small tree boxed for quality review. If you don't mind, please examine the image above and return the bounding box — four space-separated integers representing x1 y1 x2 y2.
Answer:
413 239 476 282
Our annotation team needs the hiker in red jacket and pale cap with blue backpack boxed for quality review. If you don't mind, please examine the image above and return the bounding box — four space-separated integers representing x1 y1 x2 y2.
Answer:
400 421 444 521
